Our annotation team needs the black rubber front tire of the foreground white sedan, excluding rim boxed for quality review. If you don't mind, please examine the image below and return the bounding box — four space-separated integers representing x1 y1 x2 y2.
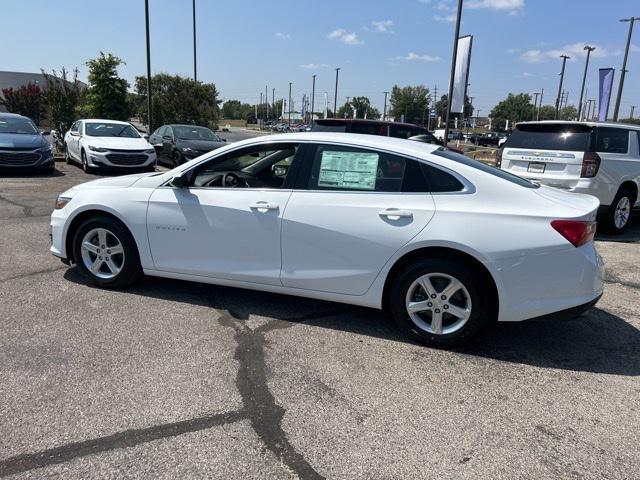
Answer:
73 217 143 288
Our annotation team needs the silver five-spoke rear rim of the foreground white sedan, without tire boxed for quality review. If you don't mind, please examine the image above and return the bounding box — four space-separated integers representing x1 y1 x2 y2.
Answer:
405 273 472 335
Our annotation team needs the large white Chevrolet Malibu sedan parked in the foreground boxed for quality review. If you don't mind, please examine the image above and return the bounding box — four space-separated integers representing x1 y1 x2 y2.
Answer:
51 133 603 346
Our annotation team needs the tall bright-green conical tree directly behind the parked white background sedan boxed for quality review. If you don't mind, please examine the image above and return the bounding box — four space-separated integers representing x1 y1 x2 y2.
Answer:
86 52 130 120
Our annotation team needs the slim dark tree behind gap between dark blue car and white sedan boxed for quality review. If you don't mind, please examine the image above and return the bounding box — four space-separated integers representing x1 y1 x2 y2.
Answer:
42 67 84 133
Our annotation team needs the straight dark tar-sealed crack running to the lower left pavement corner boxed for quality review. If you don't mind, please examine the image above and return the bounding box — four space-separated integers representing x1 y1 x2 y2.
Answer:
0 410 246 477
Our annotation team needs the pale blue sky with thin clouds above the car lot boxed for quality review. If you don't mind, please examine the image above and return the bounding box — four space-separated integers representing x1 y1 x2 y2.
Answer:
0 0 640 116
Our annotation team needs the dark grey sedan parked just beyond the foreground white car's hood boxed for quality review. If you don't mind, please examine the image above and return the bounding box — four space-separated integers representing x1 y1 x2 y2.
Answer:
149 125 226 167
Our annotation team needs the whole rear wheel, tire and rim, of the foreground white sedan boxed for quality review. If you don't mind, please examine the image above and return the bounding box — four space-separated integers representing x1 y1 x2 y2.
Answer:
389 258 491 347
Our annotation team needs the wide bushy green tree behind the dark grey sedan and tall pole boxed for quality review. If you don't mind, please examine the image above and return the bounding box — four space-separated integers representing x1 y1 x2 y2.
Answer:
136 73 220 130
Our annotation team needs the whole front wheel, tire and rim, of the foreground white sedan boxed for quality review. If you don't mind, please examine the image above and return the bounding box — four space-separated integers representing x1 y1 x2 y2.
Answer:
73 217 142 288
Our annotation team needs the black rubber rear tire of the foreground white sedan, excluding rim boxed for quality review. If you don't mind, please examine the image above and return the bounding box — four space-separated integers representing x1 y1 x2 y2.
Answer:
389 258 495 347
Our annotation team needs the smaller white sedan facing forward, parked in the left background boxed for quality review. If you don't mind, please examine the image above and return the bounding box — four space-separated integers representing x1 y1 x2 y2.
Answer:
64 119 156 172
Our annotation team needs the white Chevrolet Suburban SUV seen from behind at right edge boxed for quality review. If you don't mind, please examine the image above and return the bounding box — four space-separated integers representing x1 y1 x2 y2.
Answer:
497 121 640 233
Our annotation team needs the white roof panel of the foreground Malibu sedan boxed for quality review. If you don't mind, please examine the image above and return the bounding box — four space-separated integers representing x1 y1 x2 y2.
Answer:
218 132 441 157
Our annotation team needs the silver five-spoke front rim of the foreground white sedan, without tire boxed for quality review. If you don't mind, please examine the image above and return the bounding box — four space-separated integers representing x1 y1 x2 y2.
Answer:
80 228 125 280
